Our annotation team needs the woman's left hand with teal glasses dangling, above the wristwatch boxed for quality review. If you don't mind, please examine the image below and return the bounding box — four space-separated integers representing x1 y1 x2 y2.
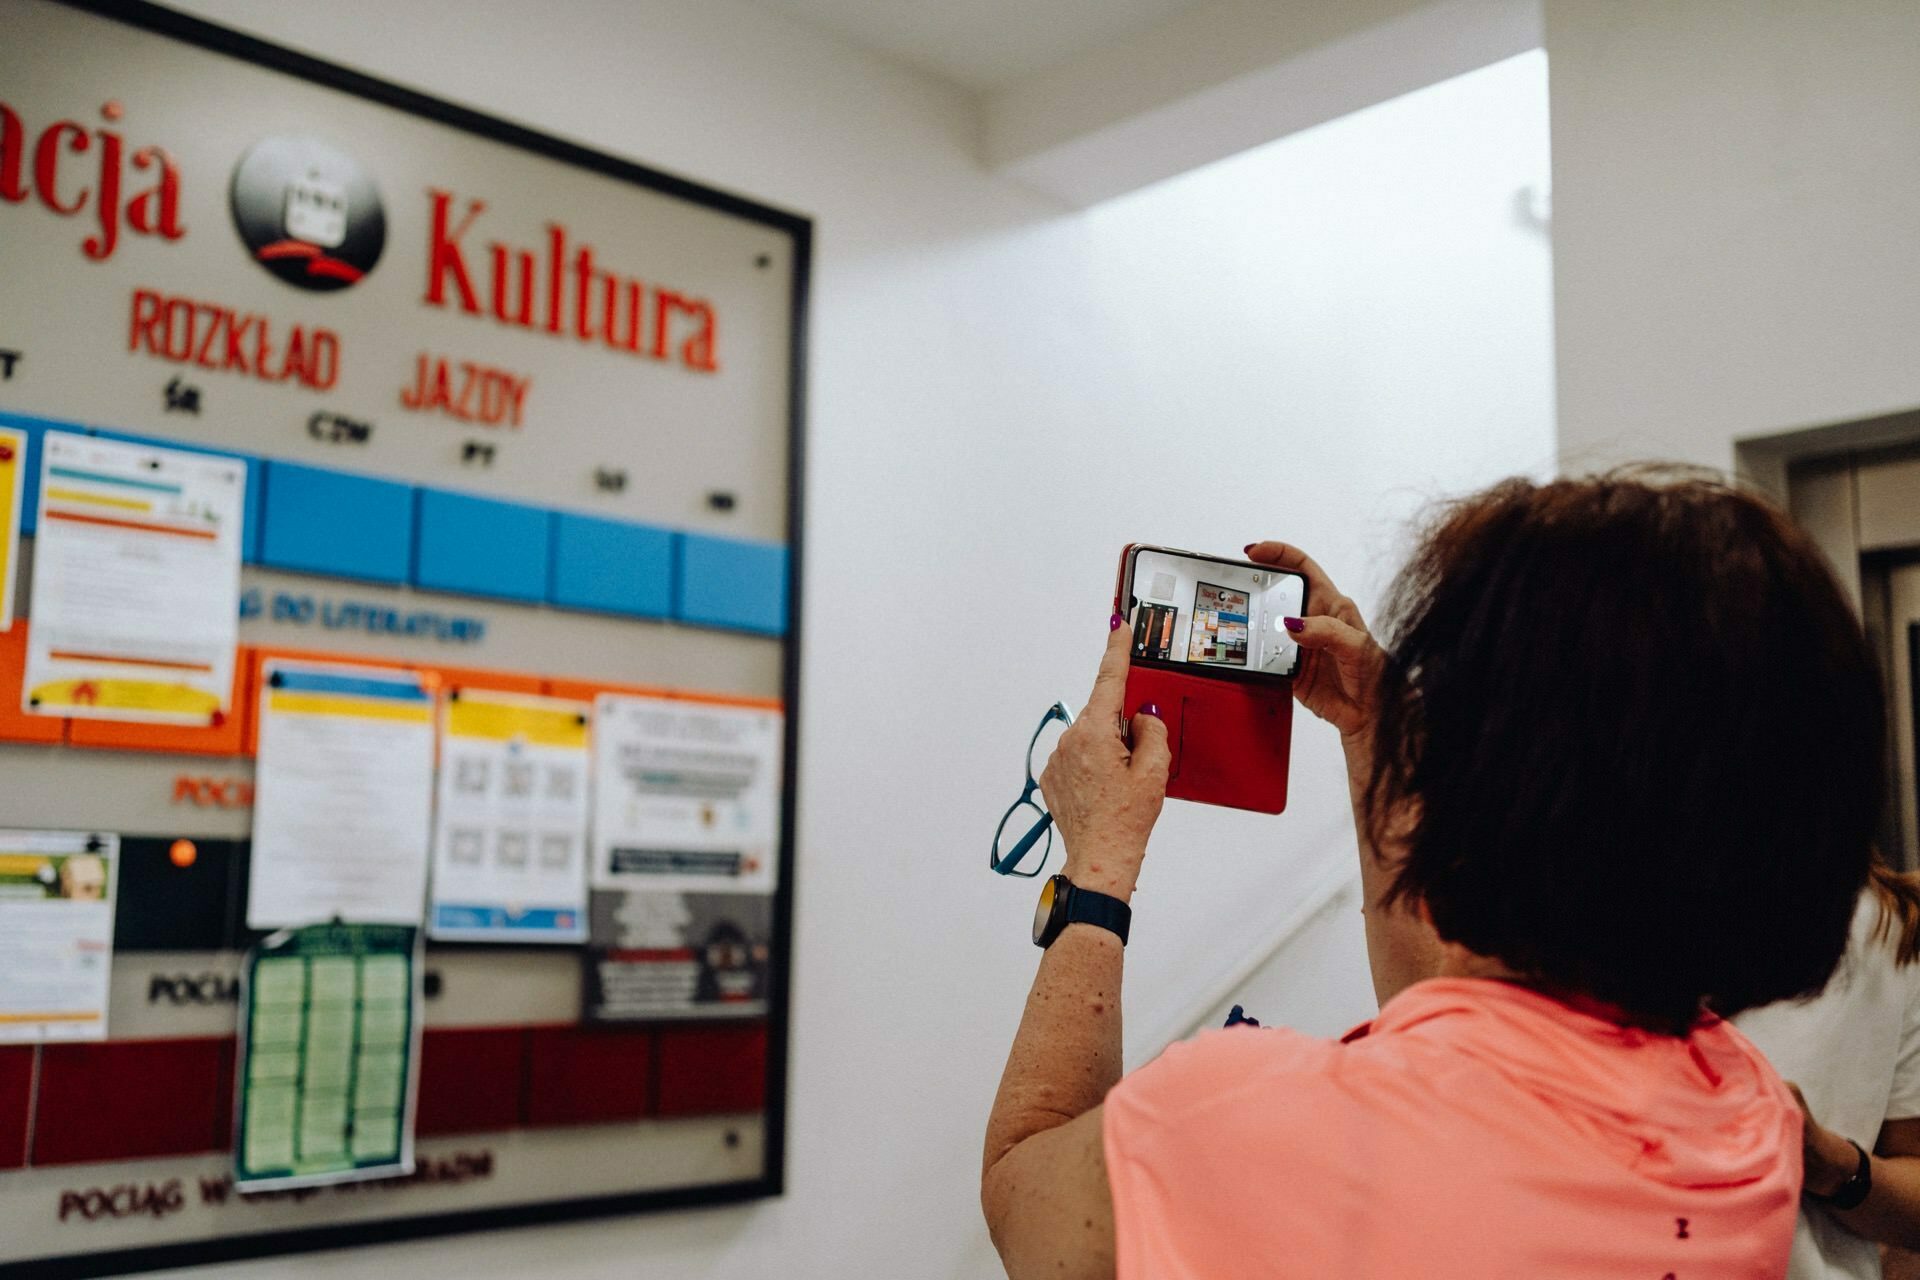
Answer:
1041 618 1173 898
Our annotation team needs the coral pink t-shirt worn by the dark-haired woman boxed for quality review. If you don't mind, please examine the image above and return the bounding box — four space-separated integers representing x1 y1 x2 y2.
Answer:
1104 979 1801 1280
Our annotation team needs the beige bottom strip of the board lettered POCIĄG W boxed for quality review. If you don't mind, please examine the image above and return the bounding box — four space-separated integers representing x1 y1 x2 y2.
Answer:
0 1115 766 1263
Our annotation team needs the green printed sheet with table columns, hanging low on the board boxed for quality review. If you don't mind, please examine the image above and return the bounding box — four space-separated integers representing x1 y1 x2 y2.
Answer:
234 923 420 1192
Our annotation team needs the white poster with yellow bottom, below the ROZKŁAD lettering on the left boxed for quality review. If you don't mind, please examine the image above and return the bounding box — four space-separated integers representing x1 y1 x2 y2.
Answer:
21 432 246 725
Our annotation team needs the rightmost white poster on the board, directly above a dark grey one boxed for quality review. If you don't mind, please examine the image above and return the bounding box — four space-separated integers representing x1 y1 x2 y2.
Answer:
593 695 785 892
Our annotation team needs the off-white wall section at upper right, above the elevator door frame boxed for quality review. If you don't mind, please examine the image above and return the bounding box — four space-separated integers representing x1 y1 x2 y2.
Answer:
1546 0 1920 470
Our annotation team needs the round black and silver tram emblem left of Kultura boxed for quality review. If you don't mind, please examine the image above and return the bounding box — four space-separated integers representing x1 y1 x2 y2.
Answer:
232 134 386 292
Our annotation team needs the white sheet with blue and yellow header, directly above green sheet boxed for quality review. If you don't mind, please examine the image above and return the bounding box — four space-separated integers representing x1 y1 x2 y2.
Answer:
246 662 434 929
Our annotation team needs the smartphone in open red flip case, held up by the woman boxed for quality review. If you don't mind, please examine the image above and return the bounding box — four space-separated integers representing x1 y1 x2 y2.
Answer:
1114 543 1308 814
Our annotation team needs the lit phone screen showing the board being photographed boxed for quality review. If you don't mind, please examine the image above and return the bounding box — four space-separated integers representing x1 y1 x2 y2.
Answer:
1125 547 1308 679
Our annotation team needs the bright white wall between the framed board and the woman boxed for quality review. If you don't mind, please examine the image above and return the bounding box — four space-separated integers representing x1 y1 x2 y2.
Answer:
157 0 1553 1280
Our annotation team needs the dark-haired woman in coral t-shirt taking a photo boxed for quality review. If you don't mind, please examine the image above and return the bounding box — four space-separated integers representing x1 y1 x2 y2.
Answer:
981 476 1885 1280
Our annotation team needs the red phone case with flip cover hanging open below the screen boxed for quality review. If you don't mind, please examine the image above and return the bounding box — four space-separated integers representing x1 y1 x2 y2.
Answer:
1114 545 1294 814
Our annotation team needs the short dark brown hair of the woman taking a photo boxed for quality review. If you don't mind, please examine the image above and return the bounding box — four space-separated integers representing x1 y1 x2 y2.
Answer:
1365 468 1887 1032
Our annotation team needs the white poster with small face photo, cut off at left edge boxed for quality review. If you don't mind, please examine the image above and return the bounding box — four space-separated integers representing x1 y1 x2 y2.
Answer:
0 831 119 1042
